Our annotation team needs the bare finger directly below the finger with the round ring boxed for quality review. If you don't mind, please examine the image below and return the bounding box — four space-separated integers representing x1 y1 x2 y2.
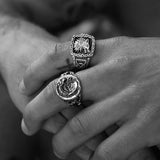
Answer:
53 87 134 157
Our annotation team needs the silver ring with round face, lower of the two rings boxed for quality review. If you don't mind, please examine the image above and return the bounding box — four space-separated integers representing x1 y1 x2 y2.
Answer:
56 72 81 106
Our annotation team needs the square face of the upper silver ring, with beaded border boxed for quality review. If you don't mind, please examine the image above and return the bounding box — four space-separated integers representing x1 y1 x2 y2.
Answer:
71 33 95 58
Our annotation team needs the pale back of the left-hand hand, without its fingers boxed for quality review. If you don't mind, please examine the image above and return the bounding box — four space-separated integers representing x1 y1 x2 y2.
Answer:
0 18 57 112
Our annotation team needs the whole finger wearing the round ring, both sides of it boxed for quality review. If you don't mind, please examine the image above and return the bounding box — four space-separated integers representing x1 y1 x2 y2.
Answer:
24 60 135 134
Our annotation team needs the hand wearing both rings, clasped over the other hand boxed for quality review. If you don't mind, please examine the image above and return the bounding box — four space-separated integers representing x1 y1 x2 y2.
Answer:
22 37 160 160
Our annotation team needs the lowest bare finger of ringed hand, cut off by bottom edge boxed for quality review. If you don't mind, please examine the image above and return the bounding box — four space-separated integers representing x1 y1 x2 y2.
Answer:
91 121 147 160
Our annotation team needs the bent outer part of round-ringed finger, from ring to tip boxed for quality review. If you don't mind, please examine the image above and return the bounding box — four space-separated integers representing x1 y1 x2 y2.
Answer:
22 70 86 135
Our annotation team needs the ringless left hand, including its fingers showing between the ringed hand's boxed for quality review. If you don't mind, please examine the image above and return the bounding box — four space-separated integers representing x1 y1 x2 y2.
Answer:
0 15 111 160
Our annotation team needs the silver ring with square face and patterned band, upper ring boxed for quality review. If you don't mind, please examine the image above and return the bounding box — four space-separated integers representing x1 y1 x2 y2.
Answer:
71 33 95 70
